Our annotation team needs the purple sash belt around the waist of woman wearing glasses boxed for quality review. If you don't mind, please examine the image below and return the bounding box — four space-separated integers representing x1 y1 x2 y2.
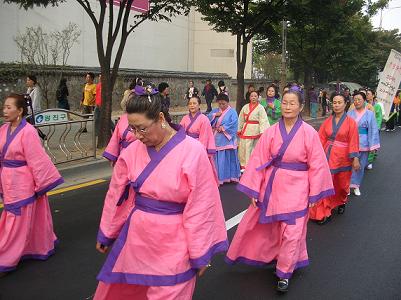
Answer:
135 194 185 215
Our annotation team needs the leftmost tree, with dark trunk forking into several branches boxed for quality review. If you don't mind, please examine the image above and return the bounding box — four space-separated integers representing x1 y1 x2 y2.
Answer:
3 0 192 148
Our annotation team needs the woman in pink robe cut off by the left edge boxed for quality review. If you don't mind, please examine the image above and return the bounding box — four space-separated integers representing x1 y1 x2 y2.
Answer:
0 94 63 275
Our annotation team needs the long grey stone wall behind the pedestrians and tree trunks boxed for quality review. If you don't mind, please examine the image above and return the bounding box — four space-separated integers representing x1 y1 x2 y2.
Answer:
0 64 271 110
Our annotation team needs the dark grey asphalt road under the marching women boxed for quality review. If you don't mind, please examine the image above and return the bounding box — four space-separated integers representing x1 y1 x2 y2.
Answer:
0 130 401 300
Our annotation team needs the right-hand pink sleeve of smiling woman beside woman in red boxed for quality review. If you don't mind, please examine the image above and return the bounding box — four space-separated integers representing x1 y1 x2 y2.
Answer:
305 129 334 203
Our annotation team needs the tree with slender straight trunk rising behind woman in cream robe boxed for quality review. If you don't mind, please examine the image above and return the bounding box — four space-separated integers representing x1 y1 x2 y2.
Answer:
194 0 286 111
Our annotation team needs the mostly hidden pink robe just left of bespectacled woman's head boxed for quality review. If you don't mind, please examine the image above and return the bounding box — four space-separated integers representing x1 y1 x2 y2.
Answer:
103 113 136 162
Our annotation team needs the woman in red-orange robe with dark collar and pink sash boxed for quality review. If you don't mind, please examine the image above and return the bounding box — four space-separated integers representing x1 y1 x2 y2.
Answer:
309 94 360 224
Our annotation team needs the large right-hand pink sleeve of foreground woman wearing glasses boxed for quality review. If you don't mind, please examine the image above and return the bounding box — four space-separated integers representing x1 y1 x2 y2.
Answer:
183 149 228 268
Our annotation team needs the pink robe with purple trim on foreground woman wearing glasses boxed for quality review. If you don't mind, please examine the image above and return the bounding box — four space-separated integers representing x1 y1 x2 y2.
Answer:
95 128 228 300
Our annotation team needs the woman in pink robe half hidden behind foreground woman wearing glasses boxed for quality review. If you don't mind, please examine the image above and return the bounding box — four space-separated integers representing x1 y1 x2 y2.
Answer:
180 96 219 185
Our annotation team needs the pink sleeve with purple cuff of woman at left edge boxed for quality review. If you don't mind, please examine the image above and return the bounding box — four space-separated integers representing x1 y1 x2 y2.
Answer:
21 125 64 196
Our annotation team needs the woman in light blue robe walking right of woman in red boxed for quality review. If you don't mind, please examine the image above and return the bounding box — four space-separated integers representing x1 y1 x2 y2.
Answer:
348 92 380 196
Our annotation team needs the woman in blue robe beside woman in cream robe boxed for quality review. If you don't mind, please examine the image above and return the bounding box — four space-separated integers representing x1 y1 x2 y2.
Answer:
208 93 241 184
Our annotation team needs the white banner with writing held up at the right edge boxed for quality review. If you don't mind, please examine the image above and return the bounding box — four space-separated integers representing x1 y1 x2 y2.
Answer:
376 49 401 120
